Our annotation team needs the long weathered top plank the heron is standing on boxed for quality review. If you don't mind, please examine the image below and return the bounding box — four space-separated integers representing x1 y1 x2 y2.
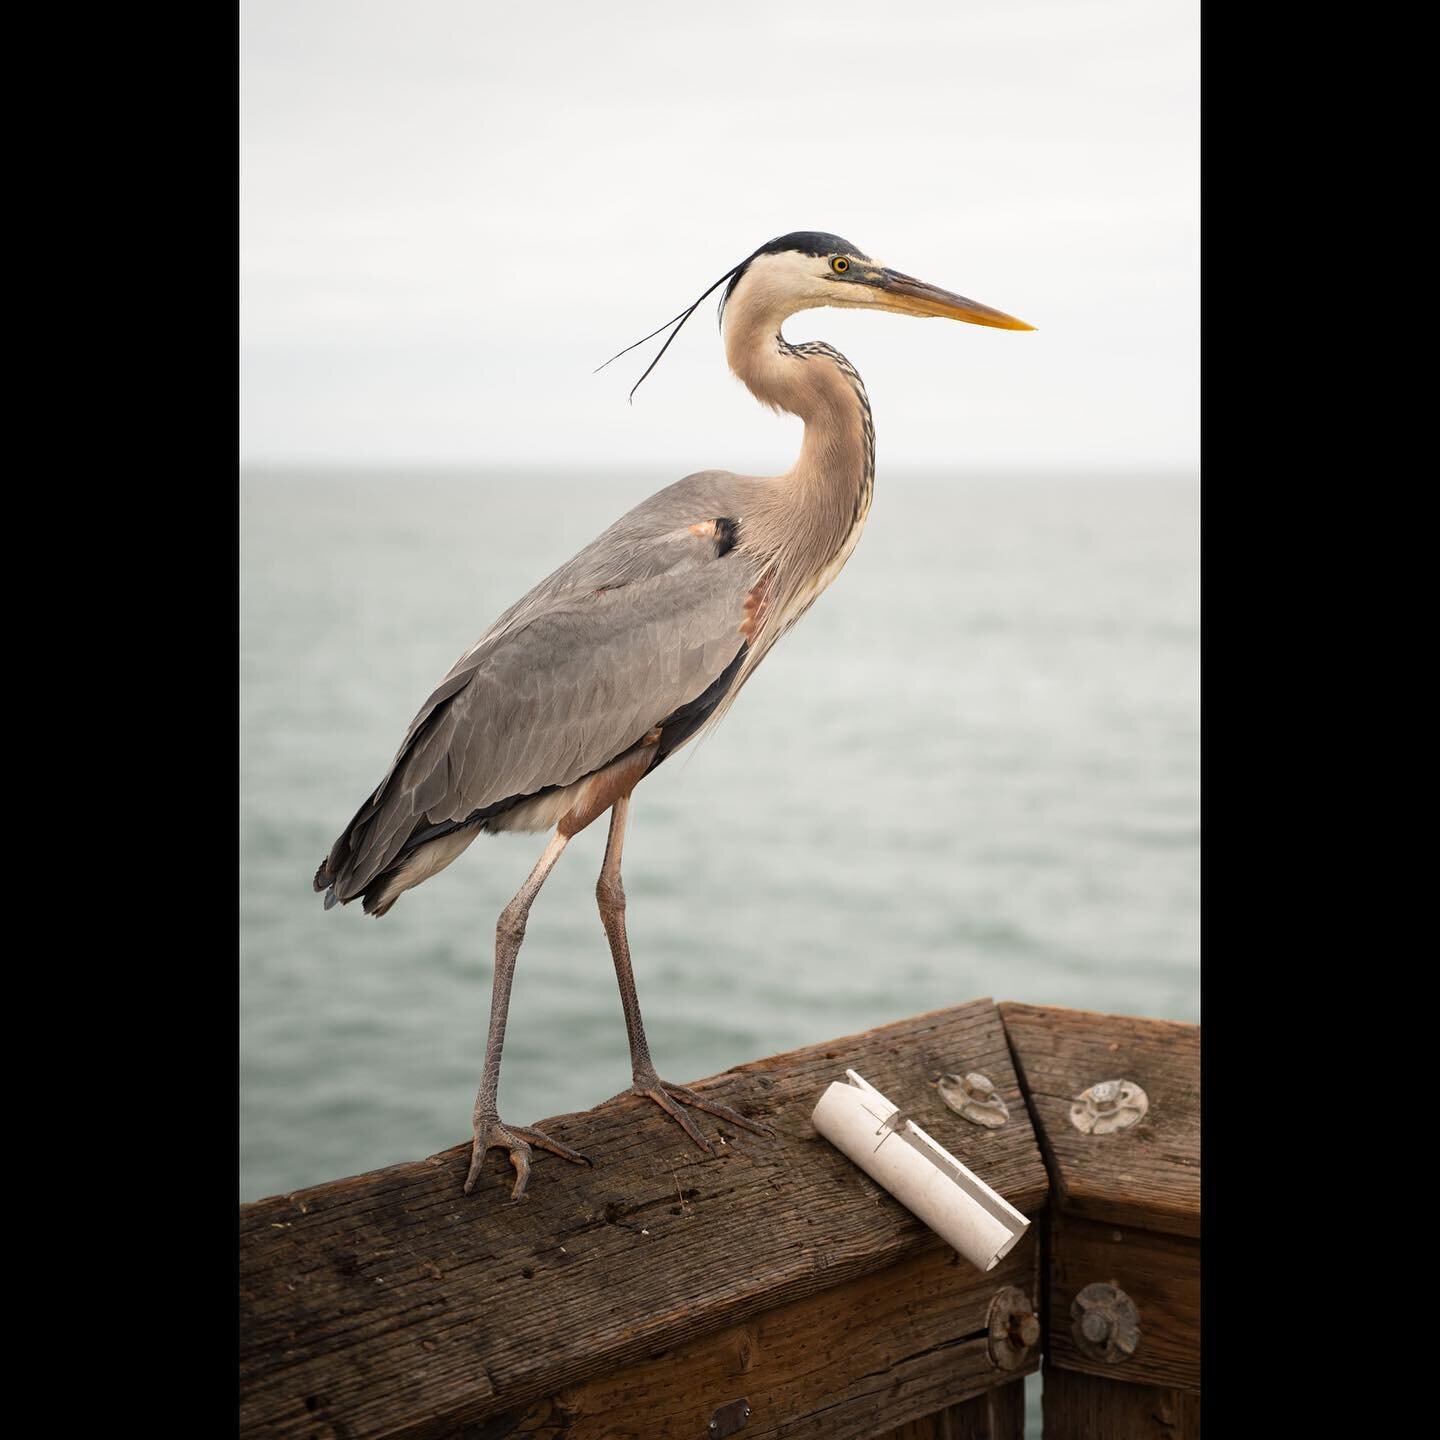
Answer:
240 999 1047 1440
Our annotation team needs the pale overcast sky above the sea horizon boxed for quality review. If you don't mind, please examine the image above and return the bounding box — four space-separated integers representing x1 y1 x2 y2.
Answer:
240 0 1200 478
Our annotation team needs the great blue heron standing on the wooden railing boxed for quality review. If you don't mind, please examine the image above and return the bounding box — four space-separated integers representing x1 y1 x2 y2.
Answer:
315 230 1032 1200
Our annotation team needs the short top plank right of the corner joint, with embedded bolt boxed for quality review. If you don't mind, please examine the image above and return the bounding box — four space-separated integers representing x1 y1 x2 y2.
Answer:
999 1001 1200 1238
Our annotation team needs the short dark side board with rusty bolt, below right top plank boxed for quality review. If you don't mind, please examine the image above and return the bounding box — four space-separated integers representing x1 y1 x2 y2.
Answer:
1047 1214 1200 1392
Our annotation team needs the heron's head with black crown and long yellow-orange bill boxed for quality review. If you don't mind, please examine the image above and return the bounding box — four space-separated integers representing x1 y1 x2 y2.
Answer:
720 230 1035 330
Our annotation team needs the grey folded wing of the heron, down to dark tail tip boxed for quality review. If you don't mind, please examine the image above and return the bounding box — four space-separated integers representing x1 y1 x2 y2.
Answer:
315 474 757 900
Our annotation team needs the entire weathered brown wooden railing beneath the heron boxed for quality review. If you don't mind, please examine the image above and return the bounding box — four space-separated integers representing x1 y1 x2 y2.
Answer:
240 1001 1200 1440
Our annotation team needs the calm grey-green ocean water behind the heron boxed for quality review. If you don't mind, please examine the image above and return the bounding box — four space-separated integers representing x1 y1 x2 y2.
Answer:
240 468 1200 1200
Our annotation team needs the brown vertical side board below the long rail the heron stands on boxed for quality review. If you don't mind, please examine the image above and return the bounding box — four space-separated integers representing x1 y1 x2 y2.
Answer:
483 1233 1040 1440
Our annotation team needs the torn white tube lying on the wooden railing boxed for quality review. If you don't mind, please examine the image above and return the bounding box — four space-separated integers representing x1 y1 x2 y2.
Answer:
811 1070 1030 1270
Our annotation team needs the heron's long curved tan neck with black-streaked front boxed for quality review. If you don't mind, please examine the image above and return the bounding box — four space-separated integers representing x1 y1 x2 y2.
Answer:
724 292 876 570
